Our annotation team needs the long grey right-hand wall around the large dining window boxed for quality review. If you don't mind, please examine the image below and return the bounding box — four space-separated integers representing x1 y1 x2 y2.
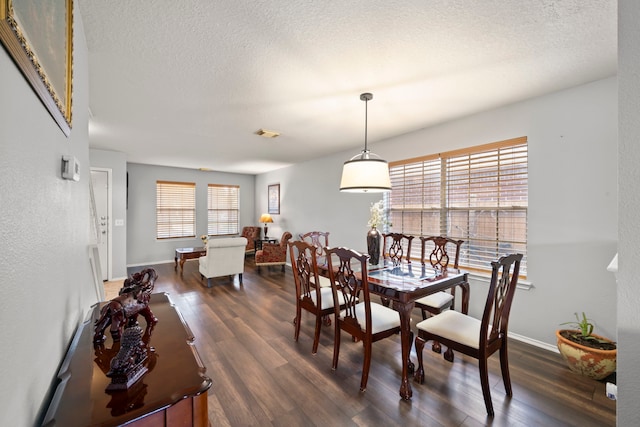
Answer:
256 78 617 348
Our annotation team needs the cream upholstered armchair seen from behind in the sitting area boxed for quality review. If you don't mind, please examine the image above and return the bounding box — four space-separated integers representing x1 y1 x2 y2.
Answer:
199 237 247 288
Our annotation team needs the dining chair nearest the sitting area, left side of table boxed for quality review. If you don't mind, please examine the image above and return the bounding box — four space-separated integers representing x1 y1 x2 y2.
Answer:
289 240 344 354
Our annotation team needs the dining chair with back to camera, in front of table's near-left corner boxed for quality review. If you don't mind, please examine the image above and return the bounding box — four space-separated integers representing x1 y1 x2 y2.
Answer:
325 247 402 391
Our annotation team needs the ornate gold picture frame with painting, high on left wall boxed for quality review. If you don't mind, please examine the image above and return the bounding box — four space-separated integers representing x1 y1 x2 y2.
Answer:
0 0 73 136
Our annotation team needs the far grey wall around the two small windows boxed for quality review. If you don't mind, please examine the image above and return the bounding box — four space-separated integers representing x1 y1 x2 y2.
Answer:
127 163 257 266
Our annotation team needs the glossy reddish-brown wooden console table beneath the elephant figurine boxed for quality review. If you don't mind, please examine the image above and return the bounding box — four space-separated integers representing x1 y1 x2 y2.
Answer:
43 293 211 427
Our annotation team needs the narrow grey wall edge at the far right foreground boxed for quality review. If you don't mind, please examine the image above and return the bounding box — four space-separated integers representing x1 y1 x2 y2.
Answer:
617 0 640 426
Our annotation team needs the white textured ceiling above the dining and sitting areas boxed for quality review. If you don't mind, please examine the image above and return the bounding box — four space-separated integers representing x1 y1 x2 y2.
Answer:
76 0 617 174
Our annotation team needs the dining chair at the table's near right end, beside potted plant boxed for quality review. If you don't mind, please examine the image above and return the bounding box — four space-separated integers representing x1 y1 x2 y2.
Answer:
415 254 522 416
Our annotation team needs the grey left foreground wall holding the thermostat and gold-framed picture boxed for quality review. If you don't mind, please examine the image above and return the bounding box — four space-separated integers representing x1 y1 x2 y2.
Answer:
0 1 97 426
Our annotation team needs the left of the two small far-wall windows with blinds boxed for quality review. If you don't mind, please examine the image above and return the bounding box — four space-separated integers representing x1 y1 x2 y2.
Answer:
156 181 196 239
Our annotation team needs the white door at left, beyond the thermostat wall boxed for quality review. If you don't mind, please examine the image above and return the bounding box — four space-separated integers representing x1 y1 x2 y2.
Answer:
91 168 111 281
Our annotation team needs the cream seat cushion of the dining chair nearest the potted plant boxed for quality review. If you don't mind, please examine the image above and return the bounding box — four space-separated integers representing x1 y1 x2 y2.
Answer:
416 310 481 348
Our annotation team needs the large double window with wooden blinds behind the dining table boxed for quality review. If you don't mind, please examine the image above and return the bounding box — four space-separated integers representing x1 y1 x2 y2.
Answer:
387 137 528 276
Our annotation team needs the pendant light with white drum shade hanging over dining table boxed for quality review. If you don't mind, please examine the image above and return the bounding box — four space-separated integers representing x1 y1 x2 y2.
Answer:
340 93 391 193
